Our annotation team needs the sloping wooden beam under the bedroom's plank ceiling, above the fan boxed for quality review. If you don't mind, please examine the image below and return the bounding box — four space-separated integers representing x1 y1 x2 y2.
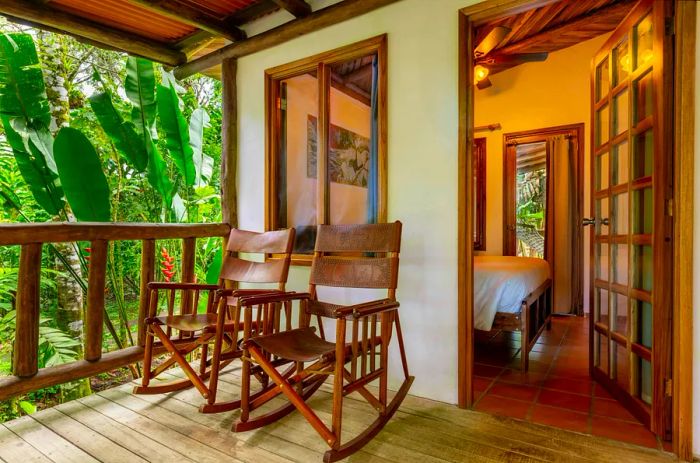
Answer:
498 2 632 55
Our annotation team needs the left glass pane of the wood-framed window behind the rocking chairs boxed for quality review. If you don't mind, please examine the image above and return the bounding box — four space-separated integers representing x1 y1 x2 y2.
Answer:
277 74 318 254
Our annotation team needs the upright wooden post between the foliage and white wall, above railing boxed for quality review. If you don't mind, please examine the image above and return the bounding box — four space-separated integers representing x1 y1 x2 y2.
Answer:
221 59 238 228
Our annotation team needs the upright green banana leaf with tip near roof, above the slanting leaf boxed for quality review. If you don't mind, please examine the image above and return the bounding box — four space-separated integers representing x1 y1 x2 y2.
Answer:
124 56 157 133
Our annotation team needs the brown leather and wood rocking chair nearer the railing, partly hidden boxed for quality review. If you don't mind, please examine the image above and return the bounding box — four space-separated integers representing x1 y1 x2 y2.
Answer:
133 228 295 413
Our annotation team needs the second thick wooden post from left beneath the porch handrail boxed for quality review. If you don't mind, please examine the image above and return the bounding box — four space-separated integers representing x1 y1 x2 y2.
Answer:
84 240 109 362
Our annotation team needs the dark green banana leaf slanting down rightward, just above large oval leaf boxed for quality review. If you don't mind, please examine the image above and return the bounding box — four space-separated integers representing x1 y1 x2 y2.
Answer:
89 91 148 172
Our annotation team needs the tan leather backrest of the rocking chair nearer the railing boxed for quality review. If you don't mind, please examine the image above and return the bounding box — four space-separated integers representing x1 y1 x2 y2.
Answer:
221 228 295 289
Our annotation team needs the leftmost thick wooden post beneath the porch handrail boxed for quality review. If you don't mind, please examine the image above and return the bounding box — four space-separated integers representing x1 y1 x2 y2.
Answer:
12 243 42 377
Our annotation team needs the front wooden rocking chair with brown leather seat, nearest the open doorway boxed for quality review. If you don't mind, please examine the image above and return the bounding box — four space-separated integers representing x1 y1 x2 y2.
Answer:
234 222 413 462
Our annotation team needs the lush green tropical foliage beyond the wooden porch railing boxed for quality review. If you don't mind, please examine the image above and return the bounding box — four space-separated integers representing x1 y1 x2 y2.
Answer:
0 26 221 422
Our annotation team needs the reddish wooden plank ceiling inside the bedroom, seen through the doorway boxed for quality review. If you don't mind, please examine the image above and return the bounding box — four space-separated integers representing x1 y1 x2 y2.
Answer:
474 0 635 74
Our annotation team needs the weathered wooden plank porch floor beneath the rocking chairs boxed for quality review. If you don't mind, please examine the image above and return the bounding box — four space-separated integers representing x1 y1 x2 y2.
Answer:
0 369 675 463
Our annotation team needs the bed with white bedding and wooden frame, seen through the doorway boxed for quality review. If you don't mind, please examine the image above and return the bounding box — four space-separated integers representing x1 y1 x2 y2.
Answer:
474 256 552 371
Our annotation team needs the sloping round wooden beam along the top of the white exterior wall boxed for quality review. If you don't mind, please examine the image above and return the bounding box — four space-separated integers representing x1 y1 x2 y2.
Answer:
175 0 398 79
